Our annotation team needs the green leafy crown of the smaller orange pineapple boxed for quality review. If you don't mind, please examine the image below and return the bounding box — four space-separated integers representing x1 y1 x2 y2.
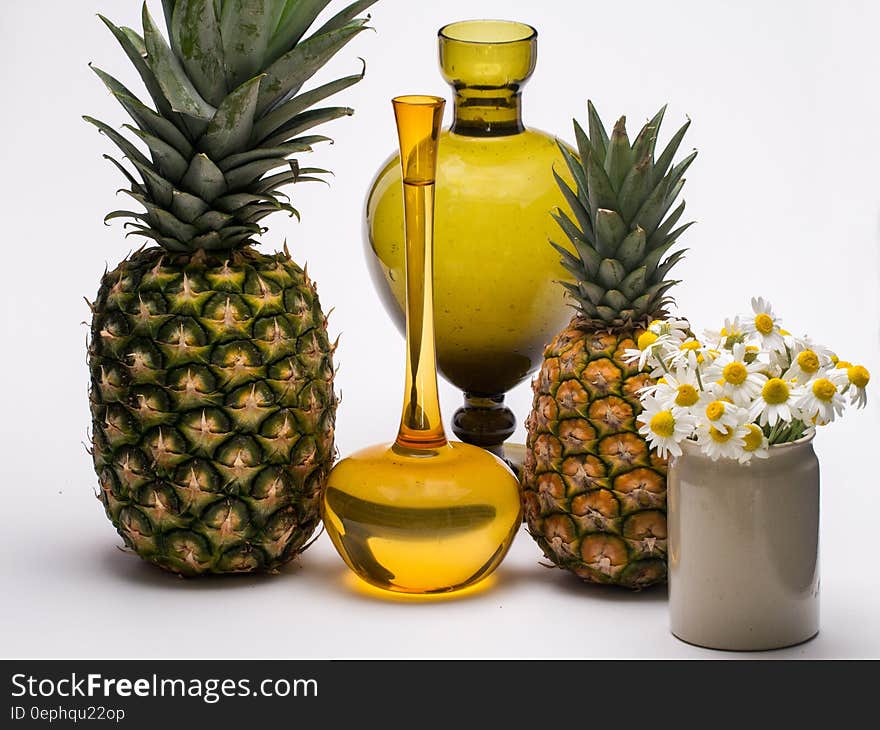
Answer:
551 102 697 331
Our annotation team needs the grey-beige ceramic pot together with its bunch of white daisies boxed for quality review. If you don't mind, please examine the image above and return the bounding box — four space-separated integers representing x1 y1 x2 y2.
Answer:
627 298 870 650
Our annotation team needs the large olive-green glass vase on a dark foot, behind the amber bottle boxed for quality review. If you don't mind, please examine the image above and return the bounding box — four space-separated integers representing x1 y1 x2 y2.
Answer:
365 21 571 462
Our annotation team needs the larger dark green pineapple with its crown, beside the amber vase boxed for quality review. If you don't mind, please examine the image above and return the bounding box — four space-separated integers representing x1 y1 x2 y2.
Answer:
86 0 375 575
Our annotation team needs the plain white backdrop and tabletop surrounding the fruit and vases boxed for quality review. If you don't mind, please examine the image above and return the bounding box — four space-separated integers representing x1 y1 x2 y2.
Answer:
0 0 880 657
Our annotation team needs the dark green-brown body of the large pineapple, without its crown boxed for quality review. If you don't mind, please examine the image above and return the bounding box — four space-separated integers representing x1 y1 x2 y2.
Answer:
89 247 337 576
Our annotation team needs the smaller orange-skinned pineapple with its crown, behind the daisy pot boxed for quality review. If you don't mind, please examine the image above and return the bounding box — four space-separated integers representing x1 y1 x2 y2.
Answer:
523 103 696 588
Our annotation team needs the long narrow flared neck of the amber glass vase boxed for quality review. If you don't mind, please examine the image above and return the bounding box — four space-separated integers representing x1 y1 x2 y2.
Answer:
394 96 447 450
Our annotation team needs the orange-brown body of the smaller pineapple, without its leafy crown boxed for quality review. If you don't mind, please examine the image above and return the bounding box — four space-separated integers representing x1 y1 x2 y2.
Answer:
522 317 667 589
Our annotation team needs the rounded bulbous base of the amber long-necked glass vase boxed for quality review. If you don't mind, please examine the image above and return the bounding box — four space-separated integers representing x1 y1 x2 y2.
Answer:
323 443 522 594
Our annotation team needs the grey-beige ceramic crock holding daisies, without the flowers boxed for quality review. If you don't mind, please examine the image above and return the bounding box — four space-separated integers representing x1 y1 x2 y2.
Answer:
668 436 819 651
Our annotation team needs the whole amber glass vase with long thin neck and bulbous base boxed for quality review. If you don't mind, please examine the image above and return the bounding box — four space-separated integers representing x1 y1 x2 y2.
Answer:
322 96 522 593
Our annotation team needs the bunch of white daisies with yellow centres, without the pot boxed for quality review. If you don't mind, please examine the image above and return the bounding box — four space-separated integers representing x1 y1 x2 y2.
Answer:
626 297 870 463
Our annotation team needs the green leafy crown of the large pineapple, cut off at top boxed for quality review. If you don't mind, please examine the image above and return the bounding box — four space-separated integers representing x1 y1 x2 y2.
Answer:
84 0 376 253
